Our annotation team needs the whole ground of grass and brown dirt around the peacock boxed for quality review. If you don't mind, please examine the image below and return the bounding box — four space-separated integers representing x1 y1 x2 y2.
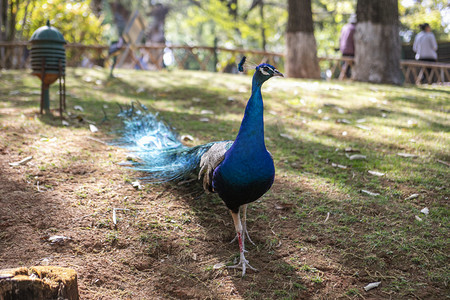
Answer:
0 69 450 299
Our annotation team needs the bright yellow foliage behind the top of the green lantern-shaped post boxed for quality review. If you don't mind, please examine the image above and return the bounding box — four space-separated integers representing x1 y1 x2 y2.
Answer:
16 0 103 44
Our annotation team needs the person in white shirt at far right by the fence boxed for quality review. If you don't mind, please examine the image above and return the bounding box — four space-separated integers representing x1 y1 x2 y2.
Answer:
413 23 437 62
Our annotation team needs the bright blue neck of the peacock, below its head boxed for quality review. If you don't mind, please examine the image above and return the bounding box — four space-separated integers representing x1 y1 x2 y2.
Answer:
235 76 266 150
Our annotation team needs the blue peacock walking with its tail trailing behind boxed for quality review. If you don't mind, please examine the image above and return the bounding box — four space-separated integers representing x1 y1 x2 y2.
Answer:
116 56 284 276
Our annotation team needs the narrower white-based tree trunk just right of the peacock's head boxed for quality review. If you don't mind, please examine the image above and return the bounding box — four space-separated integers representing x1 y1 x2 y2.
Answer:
286 0 320 78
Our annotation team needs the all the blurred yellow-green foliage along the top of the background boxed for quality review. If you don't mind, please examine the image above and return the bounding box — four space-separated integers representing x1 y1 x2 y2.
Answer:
4 0 450 56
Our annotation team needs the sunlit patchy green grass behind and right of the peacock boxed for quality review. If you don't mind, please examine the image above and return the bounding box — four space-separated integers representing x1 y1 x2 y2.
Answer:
0 69 450 299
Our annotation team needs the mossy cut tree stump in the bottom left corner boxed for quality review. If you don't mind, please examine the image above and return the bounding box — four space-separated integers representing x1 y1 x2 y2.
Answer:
0 266 78 300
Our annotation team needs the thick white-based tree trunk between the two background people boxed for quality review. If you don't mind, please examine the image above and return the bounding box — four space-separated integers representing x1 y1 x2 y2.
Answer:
353 0 402 84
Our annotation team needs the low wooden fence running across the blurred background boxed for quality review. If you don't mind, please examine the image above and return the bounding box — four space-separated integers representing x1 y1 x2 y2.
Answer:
0 42 450 84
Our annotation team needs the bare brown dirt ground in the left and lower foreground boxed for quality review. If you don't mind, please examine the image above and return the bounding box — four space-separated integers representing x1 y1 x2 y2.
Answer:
0 82 448 299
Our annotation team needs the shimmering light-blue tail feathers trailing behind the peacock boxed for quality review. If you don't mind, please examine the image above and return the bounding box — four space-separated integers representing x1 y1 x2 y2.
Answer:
112 103 225 182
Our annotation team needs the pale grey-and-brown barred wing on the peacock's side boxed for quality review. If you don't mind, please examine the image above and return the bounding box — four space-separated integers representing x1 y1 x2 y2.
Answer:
198 141 233 192
